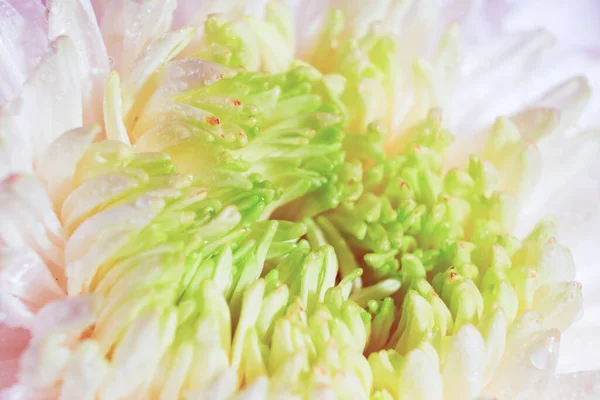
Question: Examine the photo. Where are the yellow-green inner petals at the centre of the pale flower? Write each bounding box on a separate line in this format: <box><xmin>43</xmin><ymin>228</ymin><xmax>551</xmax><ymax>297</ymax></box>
<box><xmin>51</xmin><ymin>5</ymin><xmax>580</xmax><ymax>400</ymax></box>
